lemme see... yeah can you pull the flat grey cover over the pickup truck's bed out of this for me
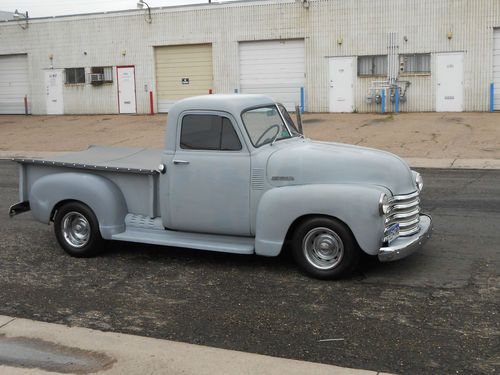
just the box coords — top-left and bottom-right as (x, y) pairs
(13, 146), (162, 174)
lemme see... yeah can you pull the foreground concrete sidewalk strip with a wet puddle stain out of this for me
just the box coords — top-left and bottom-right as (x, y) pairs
(0, 316), (386, 375)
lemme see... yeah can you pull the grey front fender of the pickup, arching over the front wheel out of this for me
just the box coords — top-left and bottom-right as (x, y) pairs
(255, 184), (389, 256)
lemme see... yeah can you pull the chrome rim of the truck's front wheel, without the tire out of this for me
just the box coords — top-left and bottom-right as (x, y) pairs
(302, 227), (344, 270)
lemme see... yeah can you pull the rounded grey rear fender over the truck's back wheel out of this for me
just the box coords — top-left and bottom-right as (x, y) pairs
(29, 172), (127, 239)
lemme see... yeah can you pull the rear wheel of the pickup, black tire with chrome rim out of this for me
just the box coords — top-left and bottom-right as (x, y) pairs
(54, 202), (104, 258)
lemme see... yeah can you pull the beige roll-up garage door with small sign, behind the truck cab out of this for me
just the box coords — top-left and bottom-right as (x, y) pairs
(155, 44), (213, 112)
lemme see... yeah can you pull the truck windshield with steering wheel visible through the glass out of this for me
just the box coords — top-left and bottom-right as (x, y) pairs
(241, 105), (292, 147)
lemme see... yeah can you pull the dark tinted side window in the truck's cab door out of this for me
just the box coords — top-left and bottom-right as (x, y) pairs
(180, 115), (241, 151)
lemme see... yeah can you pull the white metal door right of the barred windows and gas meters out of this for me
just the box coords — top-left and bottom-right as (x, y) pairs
(436, 52), (464, 112)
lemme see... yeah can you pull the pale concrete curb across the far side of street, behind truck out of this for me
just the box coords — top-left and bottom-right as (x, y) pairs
(0, 151), (500, 169)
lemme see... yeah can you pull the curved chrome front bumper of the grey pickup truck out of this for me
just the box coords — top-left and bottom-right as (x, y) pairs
(378, 215), (432, 262)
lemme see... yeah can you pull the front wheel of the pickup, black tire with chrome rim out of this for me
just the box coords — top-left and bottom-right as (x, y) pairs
(292, 217), (360, 279)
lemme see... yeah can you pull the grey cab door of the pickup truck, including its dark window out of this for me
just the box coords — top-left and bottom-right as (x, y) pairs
(162, 112), (250, 236)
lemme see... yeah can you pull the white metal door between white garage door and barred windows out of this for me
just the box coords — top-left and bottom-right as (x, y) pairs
(328, 57), (354, 112)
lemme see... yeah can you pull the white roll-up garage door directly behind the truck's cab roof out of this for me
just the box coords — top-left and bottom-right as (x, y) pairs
(239, 39), (305, 110)
